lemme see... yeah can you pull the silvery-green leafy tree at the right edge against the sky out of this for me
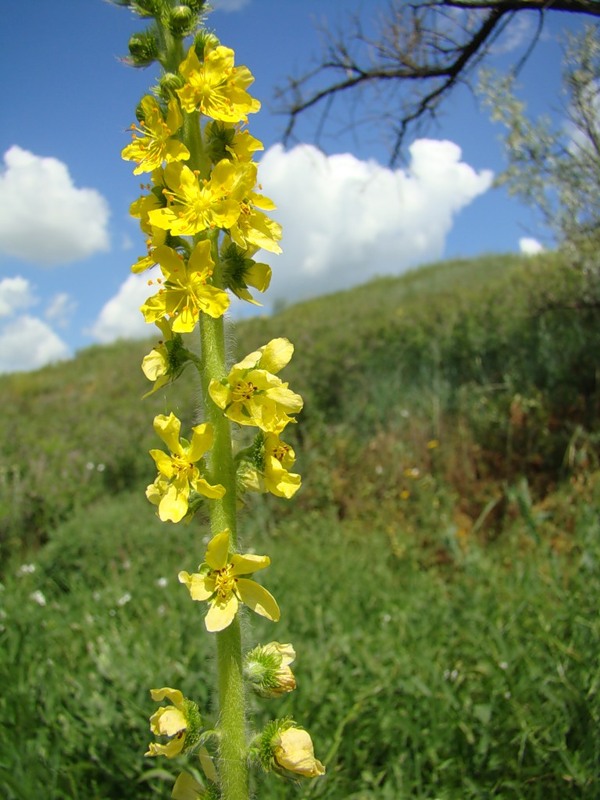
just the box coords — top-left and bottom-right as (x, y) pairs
(481, 25), (600, 252)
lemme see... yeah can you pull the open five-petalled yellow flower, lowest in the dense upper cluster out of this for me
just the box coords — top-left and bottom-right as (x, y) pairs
(141, 240), (229, 333)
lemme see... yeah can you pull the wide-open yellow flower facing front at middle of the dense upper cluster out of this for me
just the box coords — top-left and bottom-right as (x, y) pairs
(148, 159), (256, 236)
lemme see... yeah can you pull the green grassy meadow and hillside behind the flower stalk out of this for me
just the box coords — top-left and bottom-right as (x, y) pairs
(0, 254), (600, 800)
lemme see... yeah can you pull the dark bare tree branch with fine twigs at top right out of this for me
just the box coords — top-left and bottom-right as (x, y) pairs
(277, 0), (600, 163)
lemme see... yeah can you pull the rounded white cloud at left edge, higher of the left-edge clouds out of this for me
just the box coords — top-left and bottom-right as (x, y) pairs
(0, 146), (109, 265)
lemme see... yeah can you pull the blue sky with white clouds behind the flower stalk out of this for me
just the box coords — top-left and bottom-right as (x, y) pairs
(0, 0), (577, 372)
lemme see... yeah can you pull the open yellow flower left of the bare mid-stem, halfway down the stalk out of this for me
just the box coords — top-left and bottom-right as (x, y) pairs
(146, 412), (225, 522)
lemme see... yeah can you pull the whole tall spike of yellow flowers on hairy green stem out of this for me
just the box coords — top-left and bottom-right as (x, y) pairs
(120, 0), (324, 799)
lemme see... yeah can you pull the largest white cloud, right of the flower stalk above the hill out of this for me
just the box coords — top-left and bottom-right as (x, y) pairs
(259, 139), (493, 300)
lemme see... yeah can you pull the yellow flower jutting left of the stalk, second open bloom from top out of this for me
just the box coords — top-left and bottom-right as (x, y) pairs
(121, 95), (190, 175)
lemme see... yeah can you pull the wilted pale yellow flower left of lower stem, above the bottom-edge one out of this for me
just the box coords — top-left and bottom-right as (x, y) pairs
(145, 686), (202, 758)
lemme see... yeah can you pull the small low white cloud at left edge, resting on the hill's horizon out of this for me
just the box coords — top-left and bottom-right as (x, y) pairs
(0, 315), (70, 373)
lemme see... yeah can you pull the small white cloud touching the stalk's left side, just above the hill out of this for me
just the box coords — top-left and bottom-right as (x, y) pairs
(87, 267), (157, 344)
